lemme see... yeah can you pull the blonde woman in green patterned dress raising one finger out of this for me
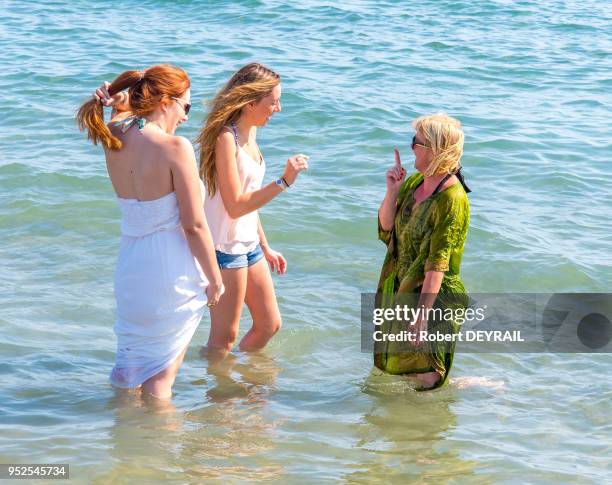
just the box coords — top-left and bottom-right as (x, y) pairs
(374, 114), (470, 390)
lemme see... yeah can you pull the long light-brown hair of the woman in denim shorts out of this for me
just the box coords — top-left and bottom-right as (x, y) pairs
(197, 62), (280, 196)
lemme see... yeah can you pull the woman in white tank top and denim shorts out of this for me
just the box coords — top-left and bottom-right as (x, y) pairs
(198, 63), (308, 356)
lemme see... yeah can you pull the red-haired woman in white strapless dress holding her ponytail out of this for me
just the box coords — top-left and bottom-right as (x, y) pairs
(77, 65), (223, 399)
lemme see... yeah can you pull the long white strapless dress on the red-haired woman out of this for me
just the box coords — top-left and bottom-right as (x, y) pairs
(110, 184), (208, 388)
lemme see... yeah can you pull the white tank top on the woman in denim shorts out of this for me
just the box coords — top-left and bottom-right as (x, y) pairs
(204, 123), (266, 254)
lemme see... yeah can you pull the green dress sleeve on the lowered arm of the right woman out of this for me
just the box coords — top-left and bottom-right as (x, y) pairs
(424, 199), (465, 272)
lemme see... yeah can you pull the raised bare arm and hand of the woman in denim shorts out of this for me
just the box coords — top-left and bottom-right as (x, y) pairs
(215, 131), (308, 219)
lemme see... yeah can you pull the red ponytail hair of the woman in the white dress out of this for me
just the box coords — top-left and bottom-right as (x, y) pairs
(76, 64), (190, 150)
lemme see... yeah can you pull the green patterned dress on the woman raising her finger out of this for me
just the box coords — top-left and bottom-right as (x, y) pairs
(374, 172), (470, 387)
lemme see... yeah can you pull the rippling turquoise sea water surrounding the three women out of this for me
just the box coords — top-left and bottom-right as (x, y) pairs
(0, 0), (612, 484)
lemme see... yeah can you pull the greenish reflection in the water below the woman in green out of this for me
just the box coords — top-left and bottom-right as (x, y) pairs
(344, 369), (476, 484)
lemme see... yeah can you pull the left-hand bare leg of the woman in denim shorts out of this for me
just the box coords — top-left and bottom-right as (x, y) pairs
(207, 268), (247, 354)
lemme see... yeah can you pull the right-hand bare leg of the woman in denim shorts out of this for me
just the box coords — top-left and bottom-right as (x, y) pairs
(240, 258), (281, 351)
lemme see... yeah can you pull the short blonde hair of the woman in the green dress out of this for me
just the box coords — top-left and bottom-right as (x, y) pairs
(412, 113), (464, 177)
